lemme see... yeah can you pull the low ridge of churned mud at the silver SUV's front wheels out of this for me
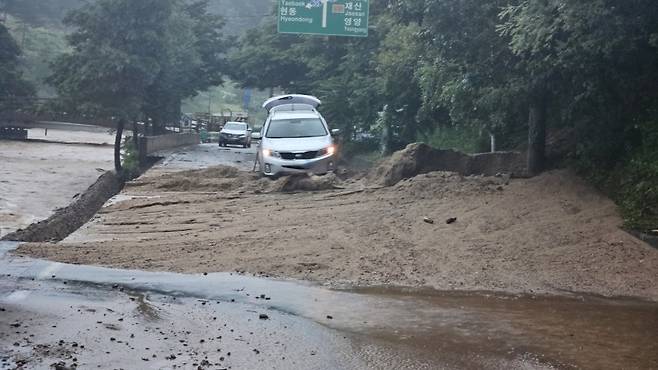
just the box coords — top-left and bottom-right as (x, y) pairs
(127, 166), (339, 193)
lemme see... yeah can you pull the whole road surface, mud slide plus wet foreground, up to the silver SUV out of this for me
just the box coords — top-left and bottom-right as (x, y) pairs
(5, 145), (658, 369)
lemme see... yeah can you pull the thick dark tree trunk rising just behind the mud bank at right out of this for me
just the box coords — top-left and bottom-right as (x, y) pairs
(528, 89), (547, 176)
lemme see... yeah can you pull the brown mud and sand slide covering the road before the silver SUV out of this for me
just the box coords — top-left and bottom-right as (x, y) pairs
(19, 144), (658, 301)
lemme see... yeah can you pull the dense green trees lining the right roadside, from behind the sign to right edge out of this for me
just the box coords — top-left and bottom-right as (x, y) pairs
(230, 0), (658, 229)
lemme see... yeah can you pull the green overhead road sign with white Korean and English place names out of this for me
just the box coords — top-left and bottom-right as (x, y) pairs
(278, 0), (370, 37)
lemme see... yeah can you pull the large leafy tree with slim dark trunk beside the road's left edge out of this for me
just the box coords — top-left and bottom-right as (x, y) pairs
(49, 0), (223, 172)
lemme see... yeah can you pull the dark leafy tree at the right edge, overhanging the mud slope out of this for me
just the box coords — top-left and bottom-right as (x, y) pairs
(500, 0), (658, 225)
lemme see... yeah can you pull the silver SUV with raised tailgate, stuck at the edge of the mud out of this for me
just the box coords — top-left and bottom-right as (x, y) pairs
(258, 95), (338, 176)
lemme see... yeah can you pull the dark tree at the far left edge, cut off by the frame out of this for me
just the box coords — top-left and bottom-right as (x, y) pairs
(0, 23), (34, 111)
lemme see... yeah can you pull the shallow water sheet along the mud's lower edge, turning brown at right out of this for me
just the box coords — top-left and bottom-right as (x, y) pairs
(0, 243), (658, 369)
